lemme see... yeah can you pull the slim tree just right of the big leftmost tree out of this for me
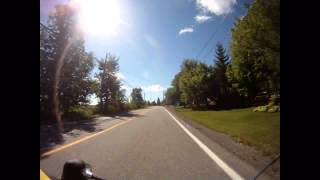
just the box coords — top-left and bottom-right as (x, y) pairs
(96, 53), (124, 113)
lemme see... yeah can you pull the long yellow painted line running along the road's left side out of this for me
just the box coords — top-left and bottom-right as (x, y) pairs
(41, 119), (132, 157)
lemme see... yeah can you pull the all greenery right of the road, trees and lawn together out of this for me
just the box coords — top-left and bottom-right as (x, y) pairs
(164, 0), (280, 154)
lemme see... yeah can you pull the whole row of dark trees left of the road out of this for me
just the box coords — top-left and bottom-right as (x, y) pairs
(40, 5), (145, 120)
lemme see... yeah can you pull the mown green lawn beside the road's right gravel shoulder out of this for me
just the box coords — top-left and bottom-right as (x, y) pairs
(176, 108), (280, 156)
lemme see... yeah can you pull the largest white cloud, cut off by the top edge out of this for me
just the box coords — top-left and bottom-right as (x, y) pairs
(196, 0), (237, 16)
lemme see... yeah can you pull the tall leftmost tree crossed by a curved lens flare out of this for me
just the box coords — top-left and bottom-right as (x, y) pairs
(40, 5), (94, 120)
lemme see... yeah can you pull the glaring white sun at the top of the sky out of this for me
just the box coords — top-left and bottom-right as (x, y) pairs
(70, 0), (123, 36)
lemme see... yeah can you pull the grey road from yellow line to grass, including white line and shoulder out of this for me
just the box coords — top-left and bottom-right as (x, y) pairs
(40, 107), (268, 180)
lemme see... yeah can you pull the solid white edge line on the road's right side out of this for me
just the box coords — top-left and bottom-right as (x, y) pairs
(163, 107), (244, 180)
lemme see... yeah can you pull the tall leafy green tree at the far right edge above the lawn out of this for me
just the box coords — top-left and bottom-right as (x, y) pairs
(228, 0), (280, 105)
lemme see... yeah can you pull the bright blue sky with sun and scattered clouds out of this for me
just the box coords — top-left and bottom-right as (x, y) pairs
(40, 0), (251, 103)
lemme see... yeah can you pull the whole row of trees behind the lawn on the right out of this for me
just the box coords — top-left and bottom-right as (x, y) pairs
(164, 0), (280, 109)
